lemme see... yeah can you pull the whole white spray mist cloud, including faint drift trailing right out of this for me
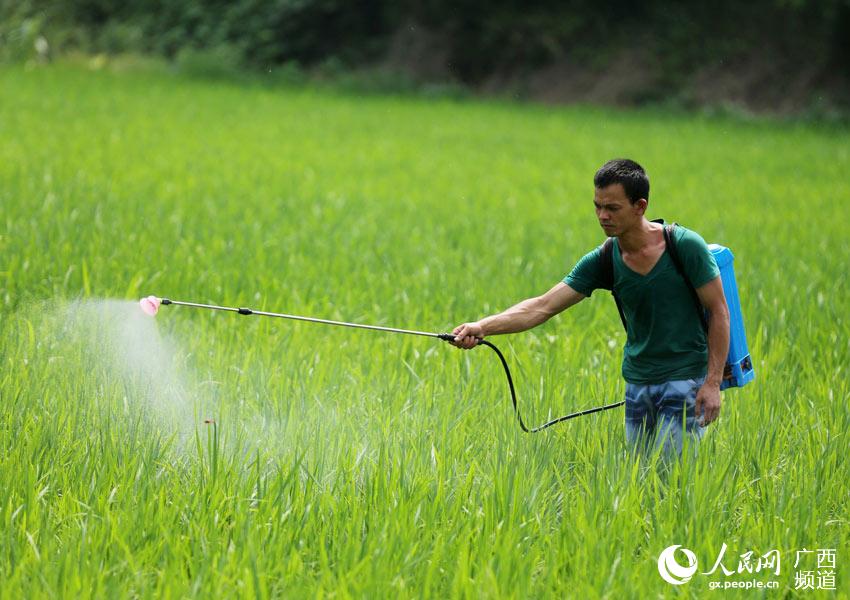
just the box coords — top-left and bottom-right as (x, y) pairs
(6, 299), (364, 456)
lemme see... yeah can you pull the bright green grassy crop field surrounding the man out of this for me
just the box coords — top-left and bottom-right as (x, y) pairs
(0, 65), (850, 598)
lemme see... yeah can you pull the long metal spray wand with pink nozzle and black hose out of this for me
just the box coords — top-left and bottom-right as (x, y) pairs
(139, 296), (624, 433)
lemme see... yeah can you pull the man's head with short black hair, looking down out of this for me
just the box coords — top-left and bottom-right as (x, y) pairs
(593, 158), (649, 236)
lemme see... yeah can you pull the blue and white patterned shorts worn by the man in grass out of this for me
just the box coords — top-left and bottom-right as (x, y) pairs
(626, 377), (705, 455)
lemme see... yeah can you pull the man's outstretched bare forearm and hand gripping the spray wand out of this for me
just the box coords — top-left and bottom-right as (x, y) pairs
(452, 282), (586, 349)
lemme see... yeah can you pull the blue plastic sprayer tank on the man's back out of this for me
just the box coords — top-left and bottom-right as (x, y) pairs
(708, 244), (756, 390)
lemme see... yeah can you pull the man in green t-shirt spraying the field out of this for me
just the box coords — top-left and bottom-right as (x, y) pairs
(452, 159), (729, 454)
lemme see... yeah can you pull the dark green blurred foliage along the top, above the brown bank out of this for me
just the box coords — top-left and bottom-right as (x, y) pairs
(0, 0), (850, 102)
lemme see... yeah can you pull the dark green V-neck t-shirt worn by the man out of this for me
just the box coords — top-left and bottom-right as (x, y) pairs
(564, 225), (720, 385)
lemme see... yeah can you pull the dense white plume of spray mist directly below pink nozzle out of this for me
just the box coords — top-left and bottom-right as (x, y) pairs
(9, 300), (202, 447)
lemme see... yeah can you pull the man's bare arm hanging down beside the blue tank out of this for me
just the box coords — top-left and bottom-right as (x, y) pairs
(696, 277), (729, 425)
